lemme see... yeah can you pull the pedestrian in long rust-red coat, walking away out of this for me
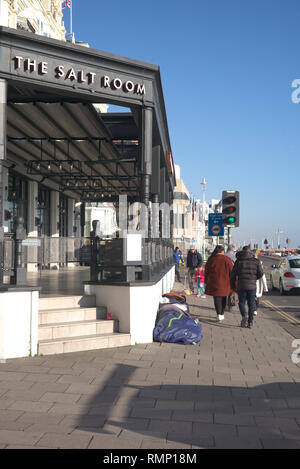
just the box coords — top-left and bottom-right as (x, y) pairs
(205, 245), (233, 321)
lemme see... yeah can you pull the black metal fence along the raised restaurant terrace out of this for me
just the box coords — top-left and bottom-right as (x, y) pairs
(0, 233), (173, 285)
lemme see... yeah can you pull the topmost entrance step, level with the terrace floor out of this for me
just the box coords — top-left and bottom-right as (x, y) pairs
(39, 295), (96, 311)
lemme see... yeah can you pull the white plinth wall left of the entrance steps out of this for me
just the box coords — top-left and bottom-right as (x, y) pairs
(0, 291), (39, 360)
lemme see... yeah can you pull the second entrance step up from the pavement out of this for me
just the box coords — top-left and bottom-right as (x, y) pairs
(39, 320), (118, 340)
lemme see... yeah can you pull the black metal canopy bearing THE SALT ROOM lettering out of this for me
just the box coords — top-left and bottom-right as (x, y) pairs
(0, 27), (175, 200)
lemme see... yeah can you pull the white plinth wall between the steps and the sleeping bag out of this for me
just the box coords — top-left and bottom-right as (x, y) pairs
(85, 267), (175, 345)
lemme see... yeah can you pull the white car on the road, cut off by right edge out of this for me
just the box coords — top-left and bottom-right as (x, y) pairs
(270, 256), (300, 295)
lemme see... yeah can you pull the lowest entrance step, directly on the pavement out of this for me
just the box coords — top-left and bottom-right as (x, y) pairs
(38, 333), (131, 355)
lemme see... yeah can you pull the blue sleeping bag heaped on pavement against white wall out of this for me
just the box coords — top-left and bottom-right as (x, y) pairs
(153, 305), (202, 345)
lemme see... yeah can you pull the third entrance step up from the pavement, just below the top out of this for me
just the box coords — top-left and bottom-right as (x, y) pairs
(39, 306), (107, 324)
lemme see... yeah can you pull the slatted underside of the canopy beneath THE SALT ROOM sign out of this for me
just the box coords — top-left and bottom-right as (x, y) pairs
(7, 102), (140, 199)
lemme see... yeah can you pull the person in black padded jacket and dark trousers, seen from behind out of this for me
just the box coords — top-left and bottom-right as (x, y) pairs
(230, 246), (264, 328)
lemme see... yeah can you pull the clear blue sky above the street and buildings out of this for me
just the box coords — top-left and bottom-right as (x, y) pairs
(64, 0), (300, 247)
